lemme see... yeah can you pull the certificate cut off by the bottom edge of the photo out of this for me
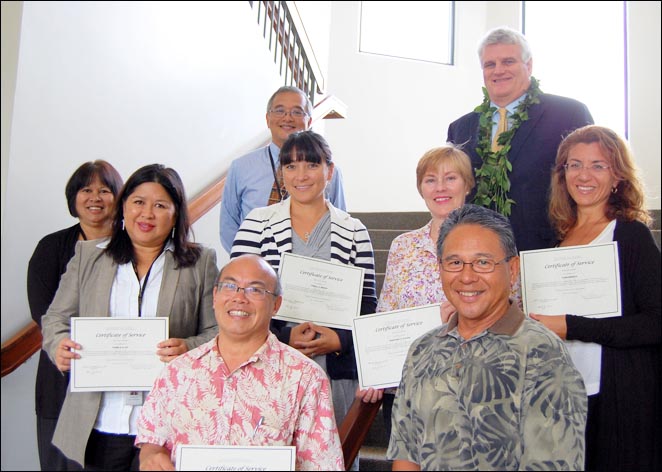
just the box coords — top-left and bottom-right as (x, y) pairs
(176, 445), (296, 470)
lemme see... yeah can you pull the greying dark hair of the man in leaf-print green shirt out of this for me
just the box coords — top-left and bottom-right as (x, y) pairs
(437, 203), (517, 259)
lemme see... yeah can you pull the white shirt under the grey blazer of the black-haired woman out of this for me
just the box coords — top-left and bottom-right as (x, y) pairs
(94, 241), (173, 435)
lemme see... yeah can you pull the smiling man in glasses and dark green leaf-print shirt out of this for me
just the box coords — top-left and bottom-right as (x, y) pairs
(387, 204), (587, 470)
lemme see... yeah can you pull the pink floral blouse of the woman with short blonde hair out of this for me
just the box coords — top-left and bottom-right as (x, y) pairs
(377, 221), (446, 312)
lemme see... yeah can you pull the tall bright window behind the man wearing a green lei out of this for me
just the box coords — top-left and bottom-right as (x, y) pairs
(523, 1), (628, 138)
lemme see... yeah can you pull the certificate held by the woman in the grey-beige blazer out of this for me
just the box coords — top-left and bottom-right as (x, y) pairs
(69, 317), (168, 392)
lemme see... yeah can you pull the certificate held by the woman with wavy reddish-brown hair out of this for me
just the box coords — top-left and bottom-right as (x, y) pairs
(520, 242), (621, 318)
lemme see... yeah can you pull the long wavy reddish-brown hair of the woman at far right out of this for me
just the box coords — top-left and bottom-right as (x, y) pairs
(549, 125), (651, 239)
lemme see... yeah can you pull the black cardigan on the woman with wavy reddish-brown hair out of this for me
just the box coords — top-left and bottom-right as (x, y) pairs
(566, 221), (662, 470)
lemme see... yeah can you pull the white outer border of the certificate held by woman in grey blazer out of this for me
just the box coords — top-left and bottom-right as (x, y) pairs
(69, 316), (169, 392)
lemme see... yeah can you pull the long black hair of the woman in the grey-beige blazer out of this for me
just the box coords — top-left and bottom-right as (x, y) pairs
(106, 164), (201, 267)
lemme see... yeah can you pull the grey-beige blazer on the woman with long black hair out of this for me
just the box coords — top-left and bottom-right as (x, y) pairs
(42, 241), (218, 465)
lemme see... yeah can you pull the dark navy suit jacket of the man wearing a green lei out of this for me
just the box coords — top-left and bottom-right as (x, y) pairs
(447, 94), (593, 251)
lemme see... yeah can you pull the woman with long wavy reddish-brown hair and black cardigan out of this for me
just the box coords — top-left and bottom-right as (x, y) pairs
(531, 126), (662, 471)
